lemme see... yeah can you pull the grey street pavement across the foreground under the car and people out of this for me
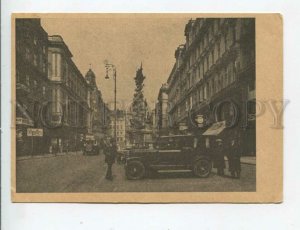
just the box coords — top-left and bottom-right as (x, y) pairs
(17, 152), (256, 192)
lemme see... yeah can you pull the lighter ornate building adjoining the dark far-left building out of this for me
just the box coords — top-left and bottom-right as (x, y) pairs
(48, 35), (92, 151)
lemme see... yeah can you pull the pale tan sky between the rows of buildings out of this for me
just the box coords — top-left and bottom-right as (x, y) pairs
(42, 15), (189, 108)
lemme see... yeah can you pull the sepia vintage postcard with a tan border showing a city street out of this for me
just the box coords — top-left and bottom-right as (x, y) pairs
(11, 13), (285, 203)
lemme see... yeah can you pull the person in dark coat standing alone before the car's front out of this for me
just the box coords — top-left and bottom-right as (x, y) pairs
(103, 138), (117, 180)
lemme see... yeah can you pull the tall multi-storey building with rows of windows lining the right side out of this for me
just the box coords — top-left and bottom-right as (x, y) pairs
(167, 18), (255, 154)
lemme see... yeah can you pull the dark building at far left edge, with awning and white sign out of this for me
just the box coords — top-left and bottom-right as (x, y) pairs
(15, 19), (48, 155)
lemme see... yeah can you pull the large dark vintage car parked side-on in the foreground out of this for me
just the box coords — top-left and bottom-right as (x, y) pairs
(125, 135), (212, 180)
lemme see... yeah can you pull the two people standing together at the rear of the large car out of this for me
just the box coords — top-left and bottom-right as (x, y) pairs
(213, 139), (241, 178)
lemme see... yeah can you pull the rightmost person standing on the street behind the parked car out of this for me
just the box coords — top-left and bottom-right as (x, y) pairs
(227, 139), (241, 178)
